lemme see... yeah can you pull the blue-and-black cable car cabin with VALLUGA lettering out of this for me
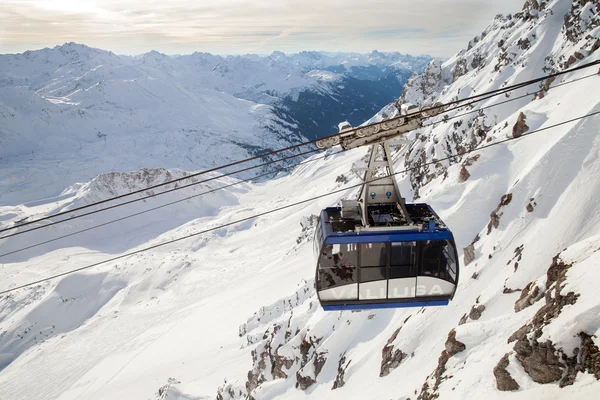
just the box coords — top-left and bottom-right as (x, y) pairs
(314, 204), (458, 311)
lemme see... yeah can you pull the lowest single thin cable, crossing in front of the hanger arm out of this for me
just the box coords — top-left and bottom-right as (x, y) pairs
(0, 111), (600, 295)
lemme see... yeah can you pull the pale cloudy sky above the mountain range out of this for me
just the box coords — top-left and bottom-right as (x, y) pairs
(0, 0), (525, 57)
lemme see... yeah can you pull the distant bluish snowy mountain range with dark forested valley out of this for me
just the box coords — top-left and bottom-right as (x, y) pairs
(0, 43), (429, 204)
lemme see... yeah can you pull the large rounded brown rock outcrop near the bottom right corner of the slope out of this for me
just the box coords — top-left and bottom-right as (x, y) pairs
(514, 338), (563, 383)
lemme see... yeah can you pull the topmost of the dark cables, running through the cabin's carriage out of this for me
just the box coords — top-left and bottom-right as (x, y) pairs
(0, 60), (600, 233)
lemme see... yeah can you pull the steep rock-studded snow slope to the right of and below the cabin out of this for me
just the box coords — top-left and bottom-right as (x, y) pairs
(211, 0), (600, 399)
